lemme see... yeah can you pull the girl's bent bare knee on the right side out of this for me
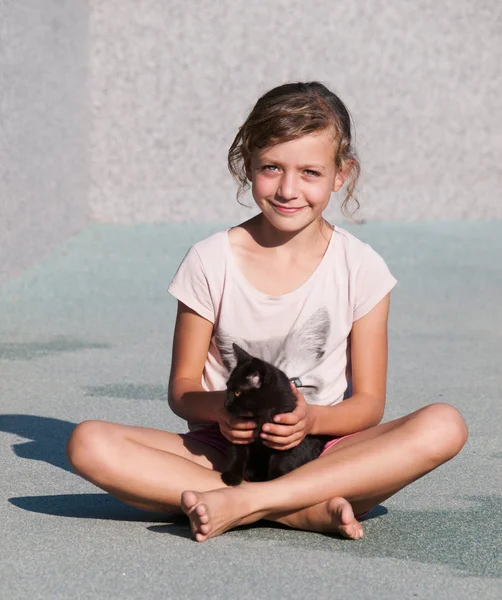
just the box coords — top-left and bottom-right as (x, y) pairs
(423, 403), (468, 460)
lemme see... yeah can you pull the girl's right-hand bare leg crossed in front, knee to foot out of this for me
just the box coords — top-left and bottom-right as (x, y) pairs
(182, 404), (467, 541)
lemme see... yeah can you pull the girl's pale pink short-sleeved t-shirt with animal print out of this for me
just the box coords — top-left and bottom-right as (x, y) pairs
(169, 227), (396, 406)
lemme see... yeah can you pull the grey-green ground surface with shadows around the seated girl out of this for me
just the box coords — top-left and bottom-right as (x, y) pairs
(0, 222), (502, 600)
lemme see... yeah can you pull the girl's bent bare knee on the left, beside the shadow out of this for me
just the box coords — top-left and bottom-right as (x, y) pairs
(66, 421), (114, 474)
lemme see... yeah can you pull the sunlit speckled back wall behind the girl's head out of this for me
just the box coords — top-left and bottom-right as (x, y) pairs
(90, 0), (502, 222)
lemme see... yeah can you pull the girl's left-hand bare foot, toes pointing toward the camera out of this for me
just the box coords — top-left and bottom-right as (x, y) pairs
(181, 483), (260, 542)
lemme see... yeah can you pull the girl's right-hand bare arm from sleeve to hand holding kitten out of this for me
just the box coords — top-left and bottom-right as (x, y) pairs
(261, 294), (390, 450)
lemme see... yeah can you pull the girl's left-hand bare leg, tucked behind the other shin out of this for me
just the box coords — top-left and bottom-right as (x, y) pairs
(67, 421), (231, 513)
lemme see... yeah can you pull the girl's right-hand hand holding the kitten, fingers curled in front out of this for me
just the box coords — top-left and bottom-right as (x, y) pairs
(260, 383), (313, 450)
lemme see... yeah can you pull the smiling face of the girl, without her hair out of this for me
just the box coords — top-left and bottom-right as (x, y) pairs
(246, 131), (345, 232)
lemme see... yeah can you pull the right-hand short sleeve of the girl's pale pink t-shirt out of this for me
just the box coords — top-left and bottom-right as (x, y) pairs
(353, 244), (397, 321)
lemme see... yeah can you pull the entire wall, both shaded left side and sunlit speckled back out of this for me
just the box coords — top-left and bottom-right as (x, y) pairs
(0, 0), (502, 280)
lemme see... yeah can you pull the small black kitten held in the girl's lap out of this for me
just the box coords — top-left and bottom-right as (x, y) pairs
(221, 344), (329, 485)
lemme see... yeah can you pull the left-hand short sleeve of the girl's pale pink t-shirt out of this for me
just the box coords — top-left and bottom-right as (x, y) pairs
(167, 246), (216, 323)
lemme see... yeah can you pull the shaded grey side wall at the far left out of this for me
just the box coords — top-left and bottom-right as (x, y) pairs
(0, 0), (89, 281)
